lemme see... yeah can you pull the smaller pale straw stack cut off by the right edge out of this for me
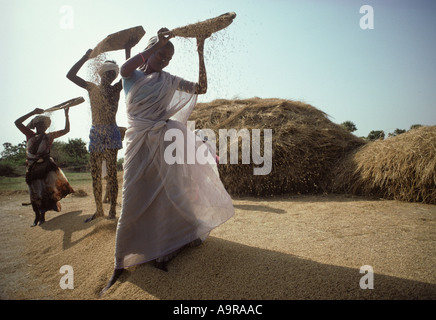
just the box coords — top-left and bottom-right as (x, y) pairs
(333, 126), (436, 204)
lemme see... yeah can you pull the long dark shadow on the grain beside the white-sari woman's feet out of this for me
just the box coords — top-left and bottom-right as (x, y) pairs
(113, 237), (436, 300)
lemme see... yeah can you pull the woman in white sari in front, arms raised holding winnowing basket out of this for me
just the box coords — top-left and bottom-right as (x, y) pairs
(103, 28), (234, 292)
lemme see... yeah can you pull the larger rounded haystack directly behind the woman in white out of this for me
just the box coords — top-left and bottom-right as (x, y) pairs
(190, 98), (365, 196)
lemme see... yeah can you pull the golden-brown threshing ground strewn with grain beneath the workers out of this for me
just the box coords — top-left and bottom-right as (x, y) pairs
(0, 184), (436, 300)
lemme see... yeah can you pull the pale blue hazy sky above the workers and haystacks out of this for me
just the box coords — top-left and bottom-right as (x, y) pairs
(0, 0), (436, 158)
